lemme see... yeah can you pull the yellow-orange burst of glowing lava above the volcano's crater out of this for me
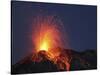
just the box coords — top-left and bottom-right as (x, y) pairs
(32, 15), (69, 56)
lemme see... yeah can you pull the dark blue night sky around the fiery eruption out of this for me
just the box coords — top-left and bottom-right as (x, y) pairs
(11, 1), (97, 64)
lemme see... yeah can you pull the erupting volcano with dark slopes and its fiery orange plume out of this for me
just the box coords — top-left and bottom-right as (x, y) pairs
(12, 15), (97, 74)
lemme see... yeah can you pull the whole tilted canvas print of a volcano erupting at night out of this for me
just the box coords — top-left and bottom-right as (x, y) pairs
(11, 1), (97, 74)
